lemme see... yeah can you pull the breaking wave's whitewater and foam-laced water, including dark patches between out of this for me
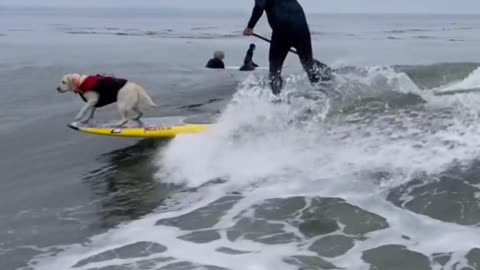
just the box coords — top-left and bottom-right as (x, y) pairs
(31, 67), (480, 270)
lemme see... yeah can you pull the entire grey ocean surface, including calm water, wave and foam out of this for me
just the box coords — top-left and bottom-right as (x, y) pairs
(0, 7), (480, 270)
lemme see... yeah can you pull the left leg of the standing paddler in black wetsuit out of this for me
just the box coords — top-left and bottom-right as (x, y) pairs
(269, 32), (290, 95)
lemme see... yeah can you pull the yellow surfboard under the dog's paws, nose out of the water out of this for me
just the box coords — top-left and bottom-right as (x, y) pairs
(68, 117), (213, 139)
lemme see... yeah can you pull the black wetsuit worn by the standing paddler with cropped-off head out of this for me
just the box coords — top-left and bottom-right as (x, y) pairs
(248, 0), (320, 94)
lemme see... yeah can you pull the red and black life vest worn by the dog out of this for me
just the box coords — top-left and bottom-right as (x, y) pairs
(75, 74), (128, 108)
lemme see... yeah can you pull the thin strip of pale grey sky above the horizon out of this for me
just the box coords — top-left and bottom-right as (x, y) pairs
(0, 0), (480, 14)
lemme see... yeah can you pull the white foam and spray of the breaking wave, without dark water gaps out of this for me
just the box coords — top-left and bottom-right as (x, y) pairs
(30, 66), (480, 270)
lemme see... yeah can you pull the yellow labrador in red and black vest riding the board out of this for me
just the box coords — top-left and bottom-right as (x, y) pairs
(57, 73), (157, 126)
